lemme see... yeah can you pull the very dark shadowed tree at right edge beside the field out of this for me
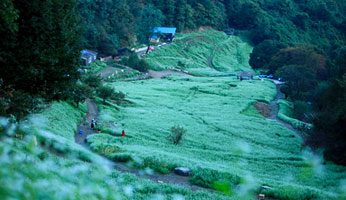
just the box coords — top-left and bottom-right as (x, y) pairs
(308, 74), (346, 165)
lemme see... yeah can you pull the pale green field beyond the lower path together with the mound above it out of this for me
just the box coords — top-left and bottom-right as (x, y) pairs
(88, 30), (346, 199)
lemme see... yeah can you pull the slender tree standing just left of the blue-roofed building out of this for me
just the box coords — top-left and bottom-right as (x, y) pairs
(137, 4), (164, 53)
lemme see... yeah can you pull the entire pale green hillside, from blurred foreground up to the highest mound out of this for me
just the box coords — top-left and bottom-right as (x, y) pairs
(0, 30), (346, 200)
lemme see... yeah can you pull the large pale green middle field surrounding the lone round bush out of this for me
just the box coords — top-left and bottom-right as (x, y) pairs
(89, 77), (340, 196)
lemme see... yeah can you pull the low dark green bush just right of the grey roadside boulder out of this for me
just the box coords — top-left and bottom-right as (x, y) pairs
(190, 169), (240, 188)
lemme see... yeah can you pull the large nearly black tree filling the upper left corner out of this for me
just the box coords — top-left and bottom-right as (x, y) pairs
(0, 0), (81, 100)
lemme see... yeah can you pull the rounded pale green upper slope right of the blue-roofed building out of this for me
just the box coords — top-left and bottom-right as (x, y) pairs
(145, 30), (252, 76)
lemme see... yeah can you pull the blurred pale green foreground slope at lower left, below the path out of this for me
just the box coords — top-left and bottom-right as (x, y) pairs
(0, 102), (230, 200)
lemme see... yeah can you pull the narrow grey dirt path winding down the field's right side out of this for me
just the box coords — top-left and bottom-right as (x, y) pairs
(269, 82), (303, 140)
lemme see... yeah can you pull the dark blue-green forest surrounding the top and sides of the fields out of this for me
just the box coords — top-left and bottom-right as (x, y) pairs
(0, 0), (346, 172)
